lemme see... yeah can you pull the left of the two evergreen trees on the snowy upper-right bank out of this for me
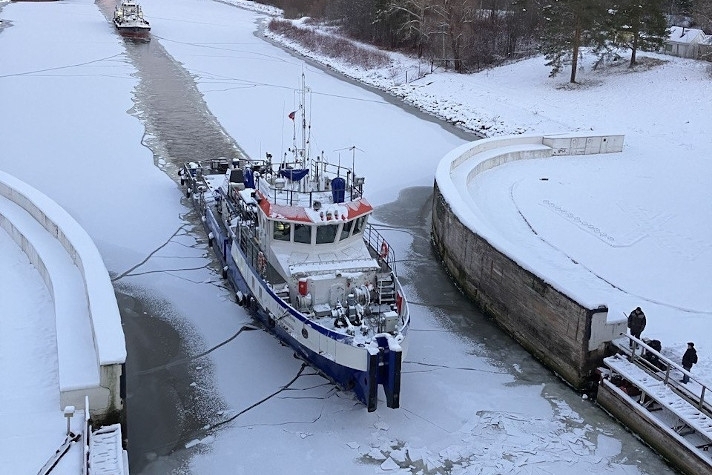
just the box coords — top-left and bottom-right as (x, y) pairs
(540, 0), (606, 83)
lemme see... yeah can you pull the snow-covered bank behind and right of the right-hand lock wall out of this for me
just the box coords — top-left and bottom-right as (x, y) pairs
(253, 2), (712, 374)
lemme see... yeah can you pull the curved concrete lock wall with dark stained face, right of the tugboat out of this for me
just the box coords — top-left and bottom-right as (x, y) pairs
(432, 135), (626, 389)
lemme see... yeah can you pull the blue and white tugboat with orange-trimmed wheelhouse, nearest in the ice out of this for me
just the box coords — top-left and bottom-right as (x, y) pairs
(180, 74), (410, 412)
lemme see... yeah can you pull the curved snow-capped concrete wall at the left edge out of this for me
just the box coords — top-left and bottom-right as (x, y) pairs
(0, 171), (126, 420)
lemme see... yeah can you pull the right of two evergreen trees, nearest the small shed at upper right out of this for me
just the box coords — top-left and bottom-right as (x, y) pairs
(612, 0), (668, 67)
